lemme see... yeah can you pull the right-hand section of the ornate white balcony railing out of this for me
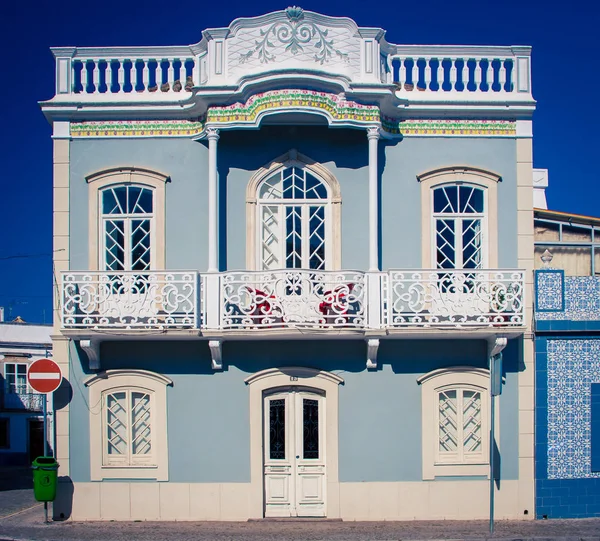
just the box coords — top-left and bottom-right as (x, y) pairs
(387, 269), (525, 328)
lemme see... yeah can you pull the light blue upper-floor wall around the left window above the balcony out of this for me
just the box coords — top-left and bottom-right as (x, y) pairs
(70, 139), (208, 270)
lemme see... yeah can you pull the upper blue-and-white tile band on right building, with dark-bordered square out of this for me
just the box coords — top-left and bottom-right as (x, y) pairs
(535, 270), (600, 321)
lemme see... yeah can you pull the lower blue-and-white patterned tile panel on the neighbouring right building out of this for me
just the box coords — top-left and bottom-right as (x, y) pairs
(538, 338), (600, 479)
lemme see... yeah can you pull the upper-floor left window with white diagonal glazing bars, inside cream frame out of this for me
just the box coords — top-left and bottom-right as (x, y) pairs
(101, 185), (154, 271)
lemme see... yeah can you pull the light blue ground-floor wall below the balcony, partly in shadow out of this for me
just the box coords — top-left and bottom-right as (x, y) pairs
(70, 340), (521, 482)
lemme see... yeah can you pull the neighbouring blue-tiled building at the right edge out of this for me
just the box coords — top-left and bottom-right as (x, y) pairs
(535, 205), (600, 518)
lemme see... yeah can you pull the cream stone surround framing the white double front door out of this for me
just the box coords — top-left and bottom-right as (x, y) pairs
(245, 367), (343, 518)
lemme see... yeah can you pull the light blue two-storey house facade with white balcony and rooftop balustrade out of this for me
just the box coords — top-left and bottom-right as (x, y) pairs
(41, 8), (535, 520)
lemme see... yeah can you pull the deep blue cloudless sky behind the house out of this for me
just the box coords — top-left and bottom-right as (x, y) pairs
(0, 0), (600, 323)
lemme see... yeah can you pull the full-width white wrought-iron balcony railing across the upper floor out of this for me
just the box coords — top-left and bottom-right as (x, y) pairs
(61, 269), (525, 337)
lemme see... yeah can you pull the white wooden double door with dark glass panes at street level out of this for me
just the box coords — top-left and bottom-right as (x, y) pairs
(263, 388), (326, 517)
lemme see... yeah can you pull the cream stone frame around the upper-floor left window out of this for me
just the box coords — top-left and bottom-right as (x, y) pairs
(86, 167), (169, 270)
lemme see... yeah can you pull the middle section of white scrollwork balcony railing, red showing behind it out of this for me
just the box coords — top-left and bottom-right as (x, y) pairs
(221, 269), (367, 329)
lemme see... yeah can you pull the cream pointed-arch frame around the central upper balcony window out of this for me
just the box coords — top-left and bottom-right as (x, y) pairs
(246, 149), (342, 270)
